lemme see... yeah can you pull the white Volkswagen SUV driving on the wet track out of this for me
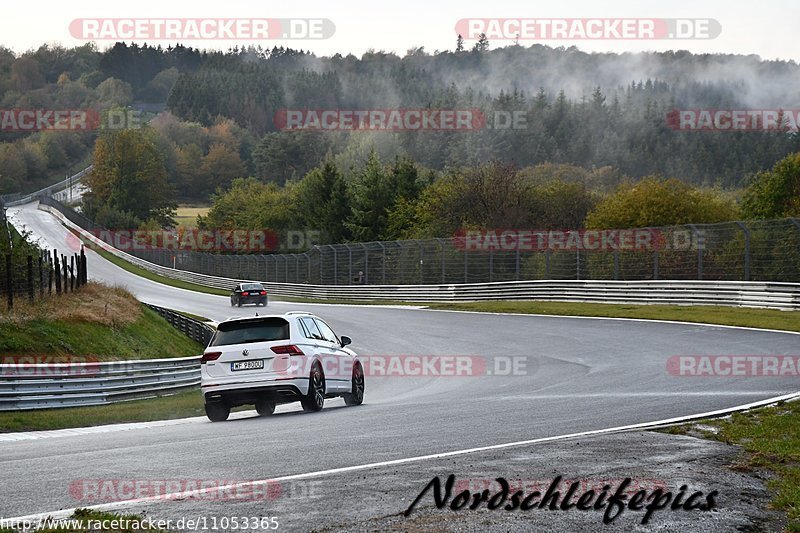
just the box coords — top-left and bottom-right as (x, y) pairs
(200, 312), (364, 422)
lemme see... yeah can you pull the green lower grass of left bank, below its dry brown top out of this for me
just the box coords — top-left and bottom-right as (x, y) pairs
(0, 308), (203, 361)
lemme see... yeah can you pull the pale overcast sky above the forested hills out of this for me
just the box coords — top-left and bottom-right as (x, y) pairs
(0, 0), (800, 62)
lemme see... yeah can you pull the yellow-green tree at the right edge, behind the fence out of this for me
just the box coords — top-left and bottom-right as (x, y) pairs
(742, 153), (800, 219)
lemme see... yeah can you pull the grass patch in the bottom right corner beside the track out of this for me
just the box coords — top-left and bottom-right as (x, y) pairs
(666, 401), (800, 533)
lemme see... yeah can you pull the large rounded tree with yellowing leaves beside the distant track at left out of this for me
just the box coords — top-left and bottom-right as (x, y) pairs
(84, 129), (176, 226)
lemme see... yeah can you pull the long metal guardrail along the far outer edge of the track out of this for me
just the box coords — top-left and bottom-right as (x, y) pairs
(40, 204), (800, 310)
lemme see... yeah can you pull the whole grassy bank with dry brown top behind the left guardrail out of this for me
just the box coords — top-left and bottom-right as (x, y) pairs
(0, 283), (202, 362)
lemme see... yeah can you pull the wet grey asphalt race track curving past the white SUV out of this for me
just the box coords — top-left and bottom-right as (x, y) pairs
(6, 204), (800, 530)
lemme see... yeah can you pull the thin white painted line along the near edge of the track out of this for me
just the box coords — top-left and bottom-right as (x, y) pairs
(5, 392), (800, 527)
